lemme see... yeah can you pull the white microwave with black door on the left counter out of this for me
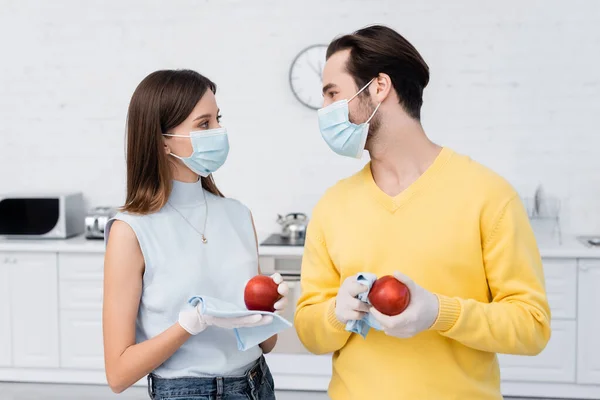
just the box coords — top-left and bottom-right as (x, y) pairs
(0, 192), (85, 239)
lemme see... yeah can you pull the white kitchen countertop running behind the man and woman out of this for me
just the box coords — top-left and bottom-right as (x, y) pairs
(0, 236), (600, 258)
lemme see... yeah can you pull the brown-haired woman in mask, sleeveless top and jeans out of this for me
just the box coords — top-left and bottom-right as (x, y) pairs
(103, 70), (287, 400)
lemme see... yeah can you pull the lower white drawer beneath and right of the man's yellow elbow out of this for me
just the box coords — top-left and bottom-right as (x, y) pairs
(498, 321), (577, 383)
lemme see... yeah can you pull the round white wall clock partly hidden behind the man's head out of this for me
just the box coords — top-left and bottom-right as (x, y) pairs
(289, 44), (327, 110)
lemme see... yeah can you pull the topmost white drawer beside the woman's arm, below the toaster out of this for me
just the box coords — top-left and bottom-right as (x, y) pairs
(58, 253), (104, 281)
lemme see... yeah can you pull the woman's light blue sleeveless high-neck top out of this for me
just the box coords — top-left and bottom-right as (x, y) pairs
(105, 181), (262, 378)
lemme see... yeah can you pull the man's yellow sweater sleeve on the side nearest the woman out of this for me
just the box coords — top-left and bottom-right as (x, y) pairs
(294, 206), (350, 354)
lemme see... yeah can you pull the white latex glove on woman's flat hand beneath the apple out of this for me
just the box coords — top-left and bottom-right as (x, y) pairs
(178, 304), (273, 335)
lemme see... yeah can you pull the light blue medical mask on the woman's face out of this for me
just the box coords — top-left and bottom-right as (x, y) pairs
(163, 128), (229, 178)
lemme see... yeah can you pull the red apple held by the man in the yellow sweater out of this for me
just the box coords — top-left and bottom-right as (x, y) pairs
(369, 275), (410, 316)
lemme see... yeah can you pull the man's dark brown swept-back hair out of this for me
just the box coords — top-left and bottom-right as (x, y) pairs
(327, 25), (429, 120)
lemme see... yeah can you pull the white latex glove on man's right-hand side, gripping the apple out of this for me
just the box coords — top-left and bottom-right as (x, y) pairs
(370, 272), (440, 338)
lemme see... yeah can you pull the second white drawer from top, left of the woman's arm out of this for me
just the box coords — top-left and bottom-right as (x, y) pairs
(59, 281), (103, 310)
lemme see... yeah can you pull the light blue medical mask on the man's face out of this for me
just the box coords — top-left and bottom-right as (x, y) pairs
(317, 78), (381, 158)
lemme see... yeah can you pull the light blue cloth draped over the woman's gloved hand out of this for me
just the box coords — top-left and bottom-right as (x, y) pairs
(189, 296), (292, 351)
